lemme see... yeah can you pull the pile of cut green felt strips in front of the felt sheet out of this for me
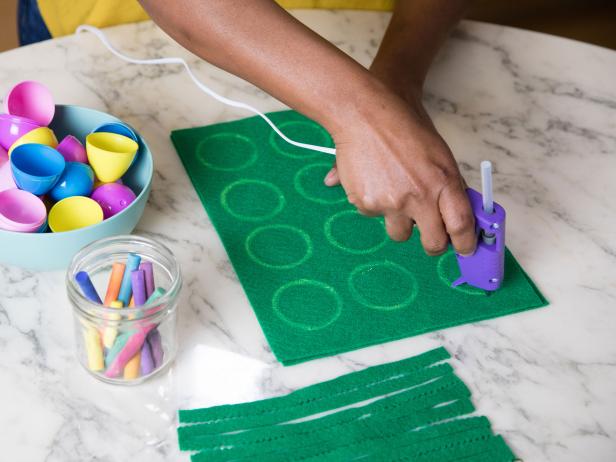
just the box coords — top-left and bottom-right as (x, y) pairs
(178, 348), (515, 462)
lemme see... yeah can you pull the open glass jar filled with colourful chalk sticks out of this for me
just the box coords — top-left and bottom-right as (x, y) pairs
(66, 235), (182, 385)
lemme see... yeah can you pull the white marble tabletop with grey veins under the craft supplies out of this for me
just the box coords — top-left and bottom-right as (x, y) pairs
(0, 11), (616, 462)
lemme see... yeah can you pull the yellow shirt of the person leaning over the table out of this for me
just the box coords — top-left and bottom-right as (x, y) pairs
(38, 0), (395, 37)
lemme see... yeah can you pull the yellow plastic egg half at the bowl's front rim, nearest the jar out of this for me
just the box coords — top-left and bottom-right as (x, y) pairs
(48, 196), (103, 233)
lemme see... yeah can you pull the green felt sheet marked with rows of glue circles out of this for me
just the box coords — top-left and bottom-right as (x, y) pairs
(171, 111), (546, 365)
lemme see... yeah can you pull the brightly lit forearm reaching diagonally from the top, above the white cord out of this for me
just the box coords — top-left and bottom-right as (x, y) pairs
(140, 0), (384, 131)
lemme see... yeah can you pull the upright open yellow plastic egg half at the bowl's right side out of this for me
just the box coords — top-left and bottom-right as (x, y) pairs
(86, 132), (139, 183)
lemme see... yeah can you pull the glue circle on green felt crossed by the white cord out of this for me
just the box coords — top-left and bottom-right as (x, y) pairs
(269, 120), (332, 159)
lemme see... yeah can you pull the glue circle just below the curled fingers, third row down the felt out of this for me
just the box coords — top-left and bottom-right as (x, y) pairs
(324, 210), (388, 255)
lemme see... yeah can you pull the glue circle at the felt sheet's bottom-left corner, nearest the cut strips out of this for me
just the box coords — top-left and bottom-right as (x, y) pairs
(272, 279), (342, 331)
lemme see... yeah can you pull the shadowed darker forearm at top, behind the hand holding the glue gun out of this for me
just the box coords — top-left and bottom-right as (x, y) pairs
(371, 0), (469, 96)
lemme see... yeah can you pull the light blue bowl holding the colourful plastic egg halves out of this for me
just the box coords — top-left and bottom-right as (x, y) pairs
(0, 105), (154, 271)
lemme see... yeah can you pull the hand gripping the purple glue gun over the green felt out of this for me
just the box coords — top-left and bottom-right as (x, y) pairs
(325, 89), (476, 255)
